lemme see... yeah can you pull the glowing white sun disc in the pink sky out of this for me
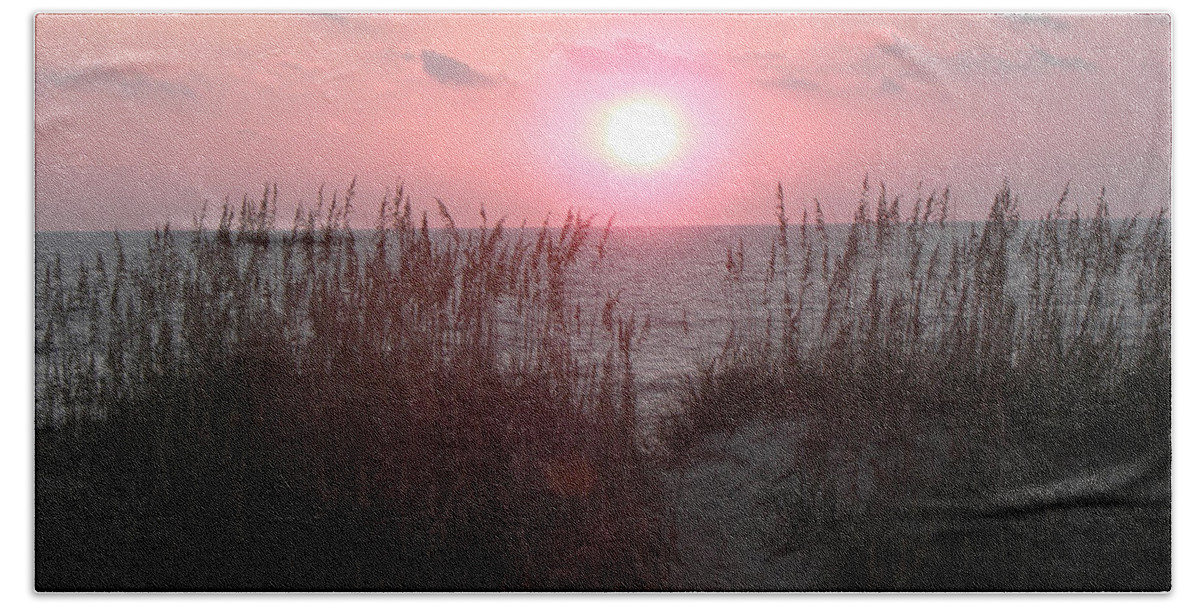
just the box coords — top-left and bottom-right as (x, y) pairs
(602, 97), (683, 170)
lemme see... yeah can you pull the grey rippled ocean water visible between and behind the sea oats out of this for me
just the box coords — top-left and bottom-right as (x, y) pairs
(35, 223), (1161, 429)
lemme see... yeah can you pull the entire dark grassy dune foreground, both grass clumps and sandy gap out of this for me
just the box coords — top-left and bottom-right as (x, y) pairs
(35, 185), (1171, 590)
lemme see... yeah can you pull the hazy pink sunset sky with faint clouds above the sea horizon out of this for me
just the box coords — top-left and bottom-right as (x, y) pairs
(35, 14), (1171, 230)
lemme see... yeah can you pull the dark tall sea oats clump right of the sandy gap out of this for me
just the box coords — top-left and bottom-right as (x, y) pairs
(667, 181), (1171, 590)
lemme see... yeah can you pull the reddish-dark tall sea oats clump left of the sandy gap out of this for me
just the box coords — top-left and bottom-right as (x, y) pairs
(37, 183), (670, 589)
